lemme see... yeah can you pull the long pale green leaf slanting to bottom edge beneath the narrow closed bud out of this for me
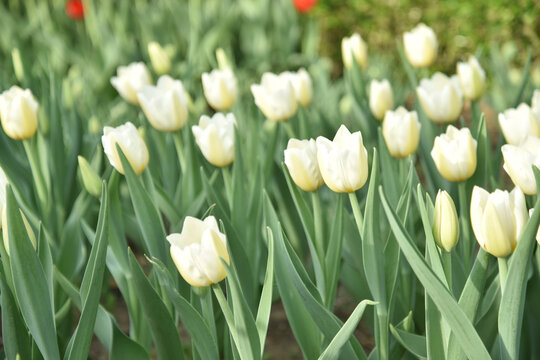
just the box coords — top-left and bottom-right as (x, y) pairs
(379, 188), (491, 359)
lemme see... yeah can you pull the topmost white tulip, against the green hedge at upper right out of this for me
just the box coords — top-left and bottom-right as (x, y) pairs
(403, 23), (438, 68)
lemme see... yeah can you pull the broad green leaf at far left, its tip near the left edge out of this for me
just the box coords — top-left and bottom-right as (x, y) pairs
(6, 185), (60, 360)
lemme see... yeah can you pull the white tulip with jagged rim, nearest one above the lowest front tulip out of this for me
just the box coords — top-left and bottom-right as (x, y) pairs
(191, 113), (236, 167)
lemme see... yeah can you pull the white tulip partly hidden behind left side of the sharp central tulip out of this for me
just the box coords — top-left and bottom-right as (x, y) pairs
(284, 139), (323, 191)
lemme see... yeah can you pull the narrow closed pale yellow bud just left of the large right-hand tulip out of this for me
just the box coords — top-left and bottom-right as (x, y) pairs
(433, 190), (459, 252)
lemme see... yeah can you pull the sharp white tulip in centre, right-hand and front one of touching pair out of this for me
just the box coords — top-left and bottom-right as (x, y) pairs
(317, 125), (368, 193)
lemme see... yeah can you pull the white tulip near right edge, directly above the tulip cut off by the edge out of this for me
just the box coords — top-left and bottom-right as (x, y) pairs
(499, 103), (540, 145)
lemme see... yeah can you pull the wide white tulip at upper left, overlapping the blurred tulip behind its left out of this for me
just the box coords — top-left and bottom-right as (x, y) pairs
(137, 75), (188, 132)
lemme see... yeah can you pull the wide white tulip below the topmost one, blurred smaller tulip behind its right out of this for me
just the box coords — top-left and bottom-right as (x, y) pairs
(416, 72), (463, 124)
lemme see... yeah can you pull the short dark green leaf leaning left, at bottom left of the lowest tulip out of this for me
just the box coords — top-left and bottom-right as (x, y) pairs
(128, 249), (184, 360)
